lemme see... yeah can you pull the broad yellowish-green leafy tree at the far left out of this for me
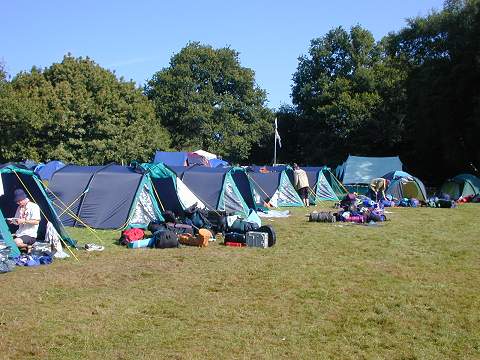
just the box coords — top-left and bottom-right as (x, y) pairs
(0, 55), (169, 164)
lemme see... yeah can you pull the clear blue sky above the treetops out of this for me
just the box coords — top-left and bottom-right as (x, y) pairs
(0, 0), (443, 108)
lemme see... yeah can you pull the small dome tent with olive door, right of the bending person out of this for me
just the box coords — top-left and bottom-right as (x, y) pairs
(382, 171), (427, 203)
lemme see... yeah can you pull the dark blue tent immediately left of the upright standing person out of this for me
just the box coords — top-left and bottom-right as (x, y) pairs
(247, 167), (303, 207)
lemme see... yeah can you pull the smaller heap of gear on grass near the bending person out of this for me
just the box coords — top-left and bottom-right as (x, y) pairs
(308, 193), (387, 224)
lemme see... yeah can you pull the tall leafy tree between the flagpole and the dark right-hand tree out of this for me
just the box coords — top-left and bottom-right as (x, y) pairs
(292, 26), (405, 165)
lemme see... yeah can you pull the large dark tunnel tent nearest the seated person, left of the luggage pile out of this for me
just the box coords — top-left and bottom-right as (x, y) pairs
(50, 164), (162, 229)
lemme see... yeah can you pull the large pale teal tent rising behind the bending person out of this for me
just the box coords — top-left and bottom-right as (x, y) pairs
(337, 155), (403, 185)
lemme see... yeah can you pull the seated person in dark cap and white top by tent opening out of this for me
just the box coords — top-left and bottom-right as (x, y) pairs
(9, 189), (40, 252)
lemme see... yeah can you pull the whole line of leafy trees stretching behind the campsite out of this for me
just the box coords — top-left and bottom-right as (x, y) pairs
(0, 0), (480, 183)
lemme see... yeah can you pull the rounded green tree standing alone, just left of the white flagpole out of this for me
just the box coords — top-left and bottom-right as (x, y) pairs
(145, 42), (273, 162)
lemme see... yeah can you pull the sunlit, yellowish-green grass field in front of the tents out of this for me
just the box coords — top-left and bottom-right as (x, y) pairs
(0, 204), (480, 359)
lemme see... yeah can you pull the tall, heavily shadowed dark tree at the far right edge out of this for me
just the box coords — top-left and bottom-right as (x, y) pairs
(386, 0), (480, 182)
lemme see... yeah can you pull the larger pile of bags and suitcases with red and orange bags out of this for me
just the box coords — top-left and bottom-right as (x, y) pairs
(119, 205), (276, 249)
